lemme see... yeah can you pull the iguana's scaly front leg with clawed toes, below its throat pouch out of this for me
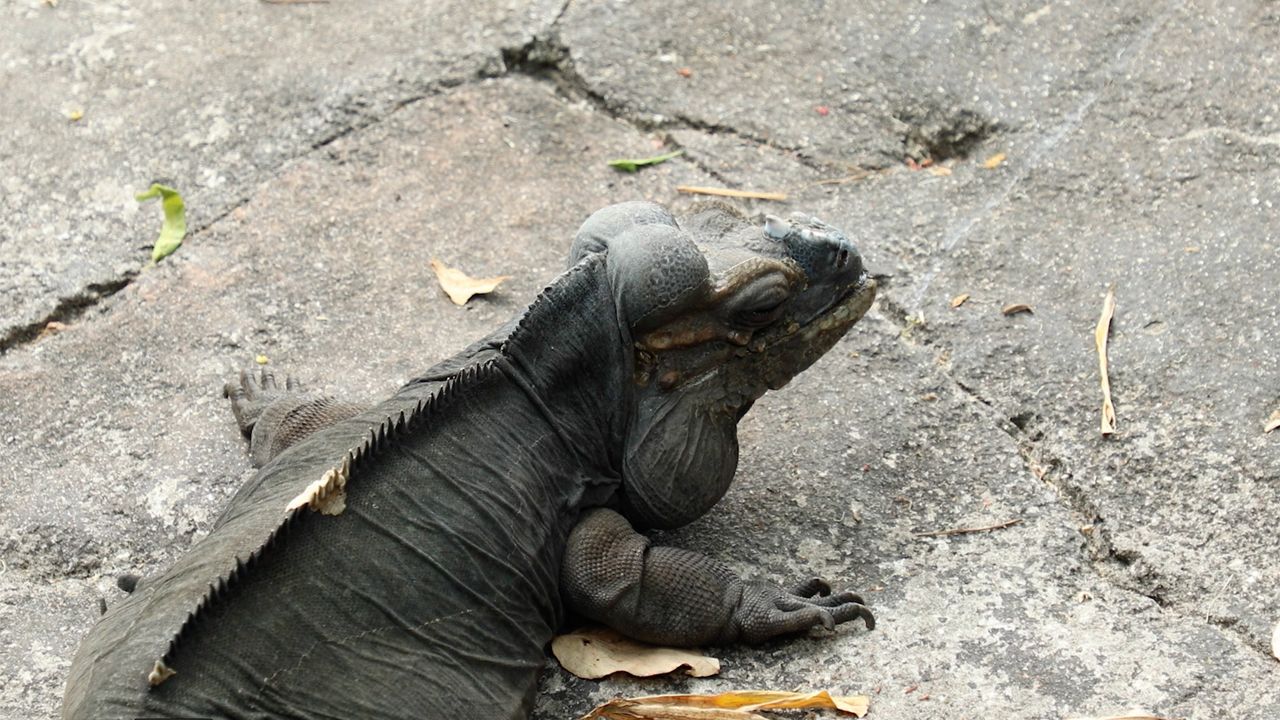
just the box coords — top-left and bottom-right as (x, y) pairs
(561, 509), (876, 646)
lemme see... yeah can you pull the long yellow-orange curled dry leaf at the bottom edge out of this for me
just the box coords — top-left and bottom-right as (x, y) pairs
(582, 691), (870, 720)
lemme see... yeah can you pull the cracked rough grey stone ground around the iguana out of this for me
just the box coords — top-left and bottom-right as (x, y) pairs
(0, 0), (1280, 720)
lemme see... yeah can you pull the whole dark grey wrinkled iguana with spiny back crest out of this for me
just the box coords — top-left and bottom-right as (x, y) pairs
(63, 202), (874, 720)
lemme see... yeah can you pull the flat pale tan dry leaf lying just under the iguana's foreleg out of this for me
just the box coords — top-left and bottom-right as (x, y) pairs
(552, 628), (719, 680)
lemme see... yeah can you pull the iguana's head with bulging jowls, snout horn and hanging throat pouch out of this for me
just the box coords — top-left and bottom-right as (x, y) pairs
(571, 202), (876, 528)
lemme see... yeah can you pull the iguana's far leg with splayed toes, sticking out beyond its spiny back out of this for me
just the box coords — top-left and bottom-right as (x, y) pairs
(223, 368), (364, 468)
